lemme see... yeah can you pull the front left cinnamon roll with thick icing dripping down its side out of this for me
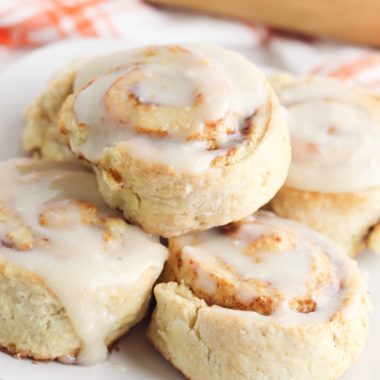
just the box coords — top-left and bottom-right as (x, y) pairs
(0, 159), (167, 364)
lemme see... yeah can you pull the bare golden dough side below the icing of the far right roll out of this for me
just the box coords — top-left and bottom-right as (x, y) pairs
(269, 186), (380, 256)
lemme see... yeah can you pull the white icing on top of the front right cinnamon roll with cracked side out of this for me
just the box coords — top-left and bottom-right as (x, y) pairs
(177, 212), (365, 324)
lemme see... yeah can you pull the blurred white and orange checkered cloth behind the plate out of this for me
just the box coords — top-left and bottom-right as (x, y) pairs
(0, 0), (380, 95)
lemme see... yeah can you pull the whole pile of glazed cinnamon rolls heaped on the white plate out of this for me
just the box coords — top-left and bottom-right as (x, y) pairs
(0, 44), (380, 380)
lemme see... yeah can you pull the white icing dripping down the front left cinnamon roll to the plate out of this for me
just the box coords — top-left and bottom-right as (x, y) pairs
(0, 159), (167, 364)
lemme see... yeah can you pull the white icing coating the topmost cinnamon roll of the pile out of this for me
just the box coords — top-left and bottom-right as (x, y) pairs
(72, 45), (269, 172)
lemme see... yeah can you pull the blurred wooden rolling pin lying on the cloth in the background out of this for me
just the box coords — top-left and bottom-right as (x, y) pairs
(149, 0), (380, 47)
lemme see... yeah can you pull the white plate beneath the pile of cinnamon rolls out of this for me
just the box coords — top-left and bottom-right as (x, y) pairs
(0, 39), (380, 380)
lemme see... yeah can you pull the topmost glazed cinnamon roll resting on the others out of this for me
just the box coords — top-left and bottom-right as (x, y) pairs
(59, 45), (290, 237)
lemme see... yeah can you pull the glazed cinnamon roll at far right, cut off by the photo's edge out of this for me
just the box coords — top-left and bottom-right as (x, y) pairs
(270, 75), (380, 255)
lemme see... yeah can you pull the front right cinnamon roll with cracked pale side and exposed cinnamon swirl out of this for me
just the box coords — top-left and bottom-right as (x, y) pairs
(148, 212), (371, 380)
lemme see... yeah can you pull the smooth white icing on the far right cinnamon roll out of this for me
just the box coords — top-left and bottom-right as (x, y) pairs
(278, 79), (380, 193)
